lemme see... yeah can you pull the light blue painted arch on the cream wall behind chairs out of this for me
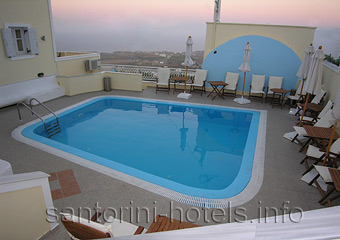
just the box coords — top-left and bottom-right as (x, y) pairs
(202, 35), (301, 92)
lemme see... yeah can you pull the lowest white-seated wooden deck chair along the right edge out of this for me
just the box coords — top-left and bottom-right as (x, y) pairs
(308, 165), (340, 207)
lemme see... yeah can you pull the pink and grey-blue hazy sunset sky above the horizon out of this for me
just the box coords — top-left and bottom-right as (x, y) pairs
(51, 0), (340, 55)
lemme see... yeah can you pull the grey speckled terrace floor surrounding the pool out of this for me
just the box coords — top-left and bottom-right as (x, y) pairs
(0, 88), (340, 239)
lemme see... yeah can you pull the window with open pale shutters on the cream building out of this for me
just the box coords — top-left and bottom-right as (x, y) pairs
(2, 23), (39, 60)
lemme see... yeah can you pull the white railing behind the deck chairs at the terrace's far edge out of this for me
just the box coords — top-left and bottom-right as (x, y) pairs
(102, 64), (196, 81)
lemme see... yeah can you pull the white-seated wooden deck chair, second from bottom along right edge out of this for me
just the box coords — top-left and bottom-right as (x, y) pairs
(300, 138), (340, 175)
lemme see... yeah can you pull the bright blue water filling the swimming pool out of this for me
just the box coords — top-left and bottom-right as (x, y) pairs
(22, 97), (260, 198)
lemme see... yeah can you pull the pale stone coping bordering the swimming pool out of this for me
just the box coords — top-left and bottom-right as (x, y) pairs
(11, 95), (267, 208)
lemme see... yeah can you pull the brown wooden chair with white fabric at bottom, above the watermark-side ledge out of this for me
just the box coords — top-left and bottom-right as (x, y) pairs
(60, 213), (147, 239)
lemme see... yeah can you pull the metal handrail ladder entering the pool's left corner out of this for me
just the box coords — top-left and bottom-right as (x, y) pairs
(17, 98), (61, 138)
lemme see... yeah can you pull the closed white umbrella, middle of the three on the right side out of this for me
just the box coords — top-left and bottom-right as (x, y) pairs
(300, 46), (325, 126)
